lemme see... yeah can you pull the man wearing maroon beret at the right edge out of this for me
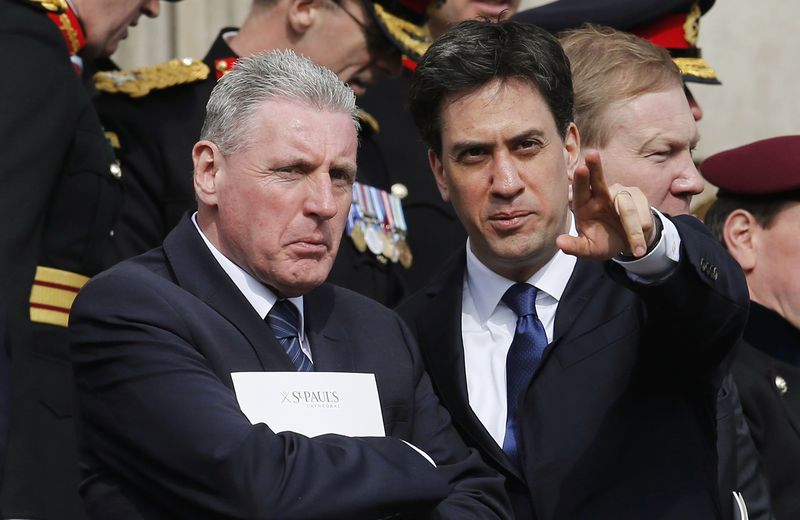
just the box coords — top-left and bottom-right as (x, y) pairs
(700, 135), (800, 520)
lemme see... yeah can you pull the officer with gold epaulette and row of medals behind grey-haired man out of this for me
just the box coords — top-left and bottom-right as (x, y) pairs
(95, 0), (426, 304)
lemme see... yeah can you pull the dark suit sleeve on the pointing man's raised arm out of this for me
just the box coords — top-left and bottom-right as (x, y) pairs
(608, 216), (749, 374)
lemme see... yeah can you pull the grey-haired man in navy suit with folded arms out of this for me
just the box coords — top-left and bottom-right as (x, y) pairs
(70, 51), (510, 519)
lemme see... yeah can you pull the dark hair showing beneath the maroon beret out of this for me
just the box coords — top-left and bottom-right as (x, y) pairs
(703, 190), (800, 246)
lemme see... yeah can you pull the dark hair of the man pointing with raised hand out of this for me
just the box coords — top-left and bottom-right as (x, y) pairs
(410, 20), (574, 155)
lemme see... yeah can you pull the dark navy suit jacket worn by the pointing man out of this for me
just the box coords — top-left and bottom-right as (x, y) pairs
(400, 217), (747, 520)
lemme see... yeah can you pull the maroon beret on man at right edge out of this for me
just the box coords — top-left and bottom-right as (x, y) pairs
(700, 135), (800, 195)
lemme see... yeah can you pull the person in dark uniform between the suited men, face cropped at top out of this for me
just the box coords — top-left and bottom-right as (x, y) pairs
(359, 0), (519, 294)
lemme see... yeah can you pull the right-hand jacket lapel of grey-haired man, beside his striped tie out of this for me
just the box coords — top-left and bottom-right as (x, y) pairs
(303, 284), (358, 372)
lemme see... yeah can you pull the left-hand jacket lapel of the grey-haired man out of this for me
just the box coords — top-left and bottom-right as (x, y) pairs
(164, 217), (295, 371)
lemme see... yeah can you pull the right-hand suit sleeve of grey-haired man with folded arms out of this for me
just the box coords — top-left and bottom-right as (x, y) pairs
(397, 316), (511, 518)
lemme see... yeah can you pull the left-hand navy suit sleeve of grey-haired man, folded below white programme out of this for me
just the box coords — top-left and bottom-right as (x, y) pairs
(70, 274), (452, 519)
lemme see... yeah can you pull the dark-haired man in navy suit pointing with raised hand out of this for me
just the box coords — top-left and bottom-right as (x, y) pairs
(401, 22), (747, 520)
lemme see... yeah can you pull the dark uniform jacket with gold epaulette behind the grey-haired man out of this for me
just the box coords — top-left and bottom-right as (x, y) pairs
(95, 28), (404, 305)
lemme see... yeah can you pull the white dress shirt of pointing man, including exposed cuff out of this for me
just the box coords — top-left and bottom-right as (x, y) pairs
(461, 211), (680, 447)
